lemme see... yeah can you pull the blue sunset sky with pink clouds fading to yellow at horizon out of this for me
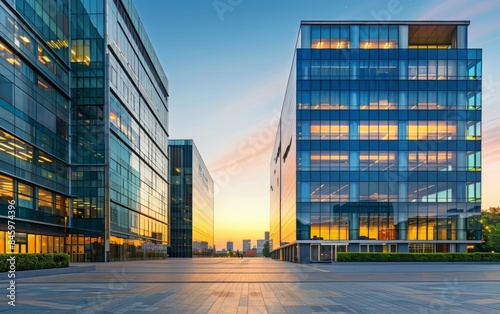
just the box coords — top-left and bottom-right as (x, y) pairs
(134, 0), (500, 250)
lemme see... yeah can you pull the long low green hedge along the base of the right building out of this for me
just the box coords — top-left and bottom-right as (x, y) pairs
(337, 253), (500, 262)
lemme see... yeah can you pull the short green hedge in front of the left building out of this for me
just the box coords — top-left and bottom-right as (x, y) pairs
(0, 253), (69, 272)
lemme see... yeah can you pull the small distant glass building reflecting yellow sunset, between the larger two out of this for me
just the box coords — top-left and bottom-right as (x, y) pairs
(168, 140), (215, 257)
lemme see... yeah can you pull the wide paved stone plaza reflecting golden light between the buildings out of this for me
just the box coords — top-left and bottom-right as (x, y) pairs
(0, 258), (500, 314)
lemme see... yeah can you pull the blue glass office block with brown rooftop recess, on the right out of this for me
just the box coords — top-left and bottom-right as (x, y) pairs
(270, 21), (482, 263)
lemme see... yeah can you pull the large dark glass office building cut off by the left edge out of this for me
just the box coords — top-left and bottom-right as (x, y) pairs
(0, 0), (168, 261)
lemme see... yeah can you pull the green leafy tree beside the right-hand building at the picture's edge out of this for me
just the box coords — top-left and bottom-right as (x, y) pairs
(478, 207), (500, 252)
